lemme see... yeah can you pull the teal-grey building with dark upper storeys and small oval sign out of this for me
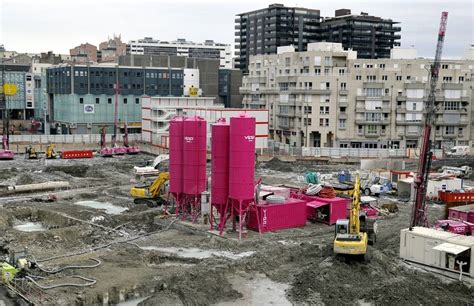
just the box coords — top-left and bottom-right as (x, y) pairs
(47, 65), (191, 134)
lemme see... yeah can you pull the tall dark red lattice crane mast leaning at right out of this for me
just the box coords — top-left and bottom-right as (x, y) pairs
(410, 12), (448, 230)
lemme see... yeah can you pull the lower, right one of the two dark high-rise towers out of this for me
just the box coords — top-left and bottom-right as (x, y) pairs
(320, 9), (401, 58)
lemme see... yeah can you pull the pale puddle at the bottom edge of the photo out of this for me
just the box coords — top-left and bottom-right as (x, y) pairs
(217, 274), (291, 306)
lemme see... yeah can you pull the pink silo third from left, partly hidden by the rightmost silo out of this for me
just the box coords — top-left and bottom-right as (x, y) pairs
(211, 118), (230, 205)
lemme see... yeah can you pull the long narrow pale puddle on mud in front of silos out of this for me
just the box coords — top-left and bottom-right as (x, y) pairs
(141, 246), (255, 260)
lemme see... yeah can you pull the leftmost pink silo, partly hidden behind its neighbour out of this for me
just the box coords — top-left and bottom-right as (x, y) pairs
(169, 117), (184, 194)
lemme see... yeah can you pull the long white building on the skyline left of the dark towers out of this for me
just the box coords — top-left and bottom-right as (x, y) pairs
(127, 37), (232, 68)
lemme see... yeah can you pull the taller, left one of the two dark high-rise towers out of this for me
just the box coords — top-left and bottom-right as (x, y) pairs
(235, 4), (320, 72)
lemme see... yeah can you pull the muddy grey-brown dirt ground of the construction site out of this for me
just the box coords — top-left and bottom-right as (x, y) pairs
(0, 154), (474, 305)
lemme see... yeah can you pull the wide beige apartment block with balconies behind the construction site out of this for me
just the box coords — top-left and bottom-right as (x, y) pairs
(240, 43), (474, 148)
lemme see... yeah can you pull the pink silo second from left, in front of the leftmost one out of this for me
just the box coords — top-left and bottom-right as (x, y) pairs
(183, 117), (207, 195)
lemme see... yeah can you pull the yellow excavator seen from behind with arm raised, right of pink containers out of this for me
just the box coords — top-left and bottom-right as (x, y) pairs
(334, 174), (377, 257)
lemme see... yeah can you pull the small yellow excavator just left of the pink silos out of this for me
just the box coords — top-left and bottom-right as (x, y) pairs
(130, 172), (170, 207)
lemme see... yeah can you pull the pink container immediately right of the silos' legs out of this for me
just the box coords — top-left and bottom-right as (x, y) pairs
(247, 199), (306, 233)
